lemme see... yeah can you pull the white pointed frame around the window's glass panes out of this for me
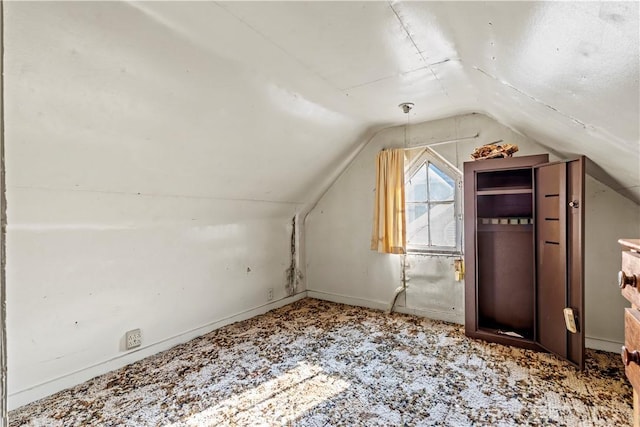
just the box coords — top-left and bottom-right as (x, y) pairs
(404, 147), (462, 255)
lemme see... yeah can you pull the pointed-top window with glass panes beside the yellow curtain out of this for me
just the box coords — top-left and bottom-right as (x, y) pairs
(405, 148), (462, 253)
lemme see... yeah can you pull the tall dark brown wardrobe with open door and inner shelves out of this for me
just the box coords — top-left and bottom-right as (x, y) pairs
(464, 154), (585, 369)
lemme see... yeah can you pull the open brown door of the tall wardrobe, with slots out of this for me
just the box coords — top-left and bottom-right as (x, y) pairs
(535, 157), (584, 369)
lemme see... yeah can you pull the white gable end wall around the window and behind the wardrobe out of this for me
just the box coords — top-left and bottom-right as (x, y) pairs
(305, 114), (640, 351)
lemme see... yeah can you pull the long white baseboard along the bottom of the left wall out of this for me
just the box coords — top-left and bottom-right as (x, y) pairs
(7, 291), (307, 411)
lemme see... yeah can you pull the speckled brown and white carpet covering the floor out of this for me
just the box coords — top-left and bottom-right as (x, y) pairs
(9, 299), (632, 427)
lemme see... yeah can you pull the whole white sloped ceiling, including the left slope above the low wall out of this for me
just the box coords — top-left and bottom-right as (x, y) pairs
(5, 2), (640, 203)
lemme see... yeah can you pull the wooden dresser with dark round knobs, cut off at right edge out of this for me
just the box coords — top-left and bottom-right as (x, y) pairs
(618, 239), (640, 427)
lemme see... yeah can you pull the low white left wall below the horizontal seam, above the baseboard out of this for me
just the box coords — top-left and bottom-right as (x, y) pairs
(7, 193), (302, 407)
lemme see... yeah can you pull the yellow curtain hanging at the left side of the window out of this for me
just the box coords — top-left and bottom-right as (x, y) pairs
(371, 149), (407, 254)
